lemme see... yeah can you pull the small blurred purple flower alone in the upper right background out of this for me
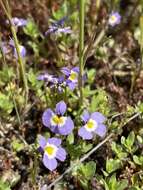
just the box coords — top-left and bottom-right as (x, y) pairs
(108, 12), (121, 26)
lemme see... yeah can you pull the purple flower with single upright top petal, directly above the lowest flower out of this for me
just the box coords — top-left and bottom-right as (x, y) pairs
(42, 101), (74, 135)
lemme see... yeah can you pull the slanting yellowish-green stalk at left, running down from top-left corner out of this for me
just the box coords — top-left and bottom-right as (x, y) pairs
(0, 0), (28, 104)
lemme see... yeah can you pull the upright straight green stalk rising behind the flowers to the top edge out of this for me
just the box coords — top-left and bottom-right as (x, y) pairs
(79, 0), (85, 105)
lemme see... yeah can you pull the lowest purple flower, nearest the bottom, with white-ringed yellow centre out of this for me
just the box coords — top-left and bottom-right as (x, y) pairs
(39, 136), (67, 171)
